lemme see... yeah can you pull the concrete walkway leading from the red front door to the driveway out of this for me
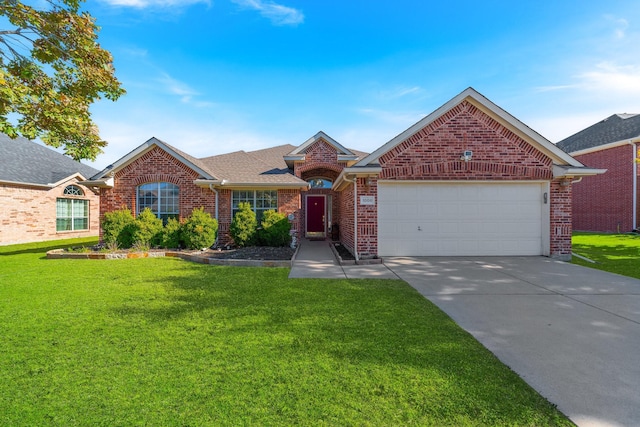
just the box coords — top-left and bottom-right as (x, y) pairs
(289, 240), (399, 279)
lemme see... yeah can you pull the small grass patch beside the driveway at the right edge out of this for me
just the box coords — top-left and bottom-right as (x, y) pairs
(572, 233), (640, 279)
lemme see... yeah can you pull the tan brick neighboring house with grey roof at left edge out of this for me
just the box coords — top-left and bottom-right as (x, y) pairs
(0, 134), (100, 245)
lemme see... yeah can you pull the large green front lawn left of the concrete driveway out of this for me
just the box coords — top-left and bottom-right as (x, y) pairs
(0, 241), (571, 426)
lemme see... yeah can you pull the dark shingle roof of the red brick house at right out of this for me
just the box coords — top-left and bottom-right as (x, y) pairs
(556, 114), (640, 153)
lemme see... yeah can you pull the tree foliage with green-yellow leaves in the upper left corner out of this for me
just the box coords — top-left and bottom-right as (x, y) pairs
(0, 0), (124, 160)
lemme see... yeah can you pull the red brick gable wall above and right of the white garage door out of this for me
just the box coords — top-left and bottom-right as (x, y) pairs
(370, 101), (571, 257)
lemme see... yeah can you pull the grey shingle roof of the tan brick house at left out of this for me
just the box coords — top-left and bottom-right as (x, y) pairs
(0, 133), (98, 186)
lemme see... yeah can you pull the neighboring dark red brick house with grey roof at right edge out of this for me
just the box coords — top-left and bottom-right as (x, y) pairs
(557, 114), (640, 233)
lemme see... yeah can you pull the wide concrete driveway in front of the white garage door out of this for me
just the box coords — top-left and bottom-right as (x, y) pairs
(385, 257), (640, 426)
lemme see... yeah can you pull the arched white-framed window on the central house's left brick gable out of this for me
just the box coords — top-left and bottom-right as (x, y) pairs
(136, 182), (180, 222)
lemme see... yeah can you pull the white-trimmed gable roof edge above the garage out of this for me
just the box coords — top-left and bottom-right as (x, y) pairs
(354, 87), (584, 168)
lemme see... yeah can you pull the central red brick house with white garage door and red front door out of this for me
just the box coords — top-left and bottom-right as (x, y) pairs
(84, 88), (602, 258)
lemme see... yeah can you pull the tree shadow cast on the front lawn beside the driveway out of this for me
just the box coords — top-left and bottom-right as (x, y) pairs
(109, 266), (562, 425)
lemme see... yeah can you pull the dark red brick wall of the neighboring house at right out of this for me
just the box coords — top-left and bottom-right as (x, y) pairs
(573, 145), (640, 233)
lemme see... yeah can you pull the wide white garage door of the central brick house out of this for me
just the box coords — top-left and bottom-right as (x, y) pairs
(378, 182), (549, 256)
